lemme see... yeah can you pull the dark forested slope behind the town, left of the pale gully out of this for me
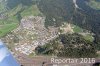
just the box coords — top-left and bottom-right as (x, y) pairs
(38, 0), (74, 27)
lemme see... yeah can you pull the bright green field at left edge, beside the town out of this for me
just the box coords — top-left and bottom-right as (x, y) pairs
(0, 13), (19, 37)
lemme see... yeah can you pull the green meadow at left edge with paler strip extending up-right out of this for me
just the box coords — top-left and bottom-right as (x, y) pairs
(0, 5), (21, 37)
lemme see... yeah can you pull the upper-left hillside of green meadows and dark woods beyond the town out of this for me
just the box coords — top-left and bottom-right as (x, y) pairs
(0, 0), (41, 37)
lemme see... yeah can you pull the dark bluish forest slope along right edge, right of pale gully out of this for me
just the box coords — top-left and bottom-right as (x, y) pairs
(72, 0), (100, 51)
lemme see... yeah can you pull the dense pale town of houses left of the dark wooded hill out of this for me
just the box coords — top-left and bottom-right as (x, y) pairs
(1, 16), (58, 55)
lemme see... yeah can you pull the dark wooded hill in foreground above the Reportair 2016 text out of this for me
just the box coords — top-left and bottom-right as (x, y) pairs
(36, 33), (97, 58)
